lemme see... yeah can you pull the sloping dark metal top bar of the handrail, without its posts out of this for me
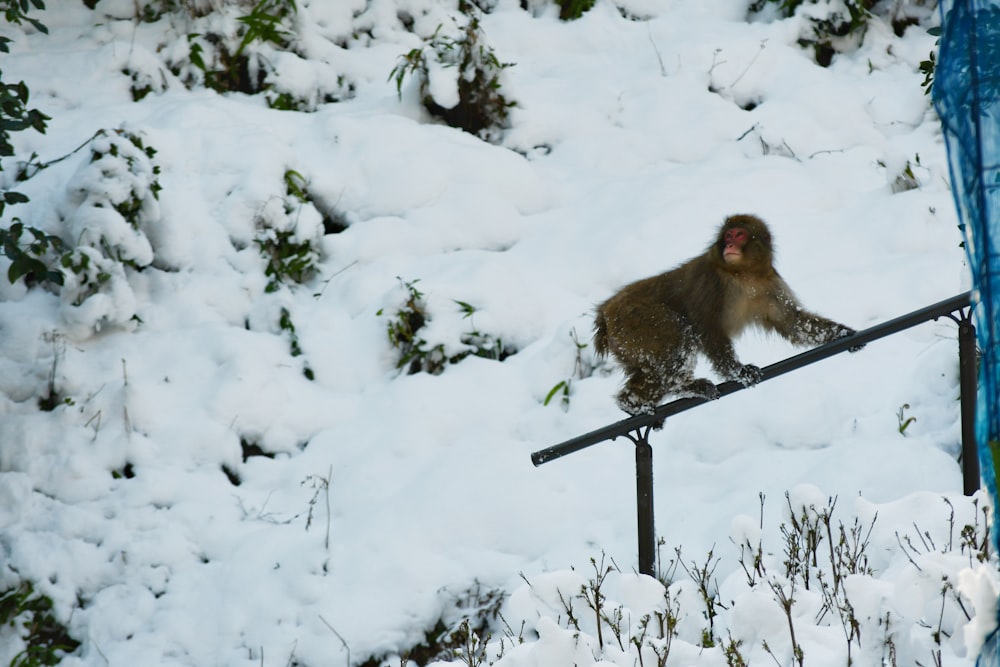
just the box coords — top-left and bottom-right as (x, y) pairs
(531, 292), (971, 466)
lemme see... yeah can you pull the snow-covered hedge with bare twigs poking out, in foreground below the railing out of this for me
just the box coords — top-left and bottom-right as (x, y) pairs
(417, 486), (996, 667)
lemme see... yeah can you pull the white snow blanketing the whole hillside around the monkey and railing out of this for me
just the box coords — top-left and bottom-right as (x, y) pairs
(0, 0), (988, 667)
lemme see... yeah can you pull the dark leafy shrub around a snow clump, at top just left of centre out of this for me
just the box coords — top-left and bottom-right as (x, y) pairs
(389, 4), (516, 142)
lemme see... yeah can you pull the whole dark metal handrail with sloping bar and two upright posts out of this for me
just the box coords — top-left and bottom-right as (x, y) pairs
(531, 292), (980, 575)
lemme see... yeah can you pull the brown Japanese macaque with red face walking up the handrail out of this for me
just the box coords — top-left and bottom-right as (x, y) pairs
(594, 215), (854, 415)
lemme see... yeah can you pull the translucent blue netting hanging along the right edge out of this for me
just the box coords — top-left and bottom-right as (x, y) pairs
(932, 0), (1000, 667)
